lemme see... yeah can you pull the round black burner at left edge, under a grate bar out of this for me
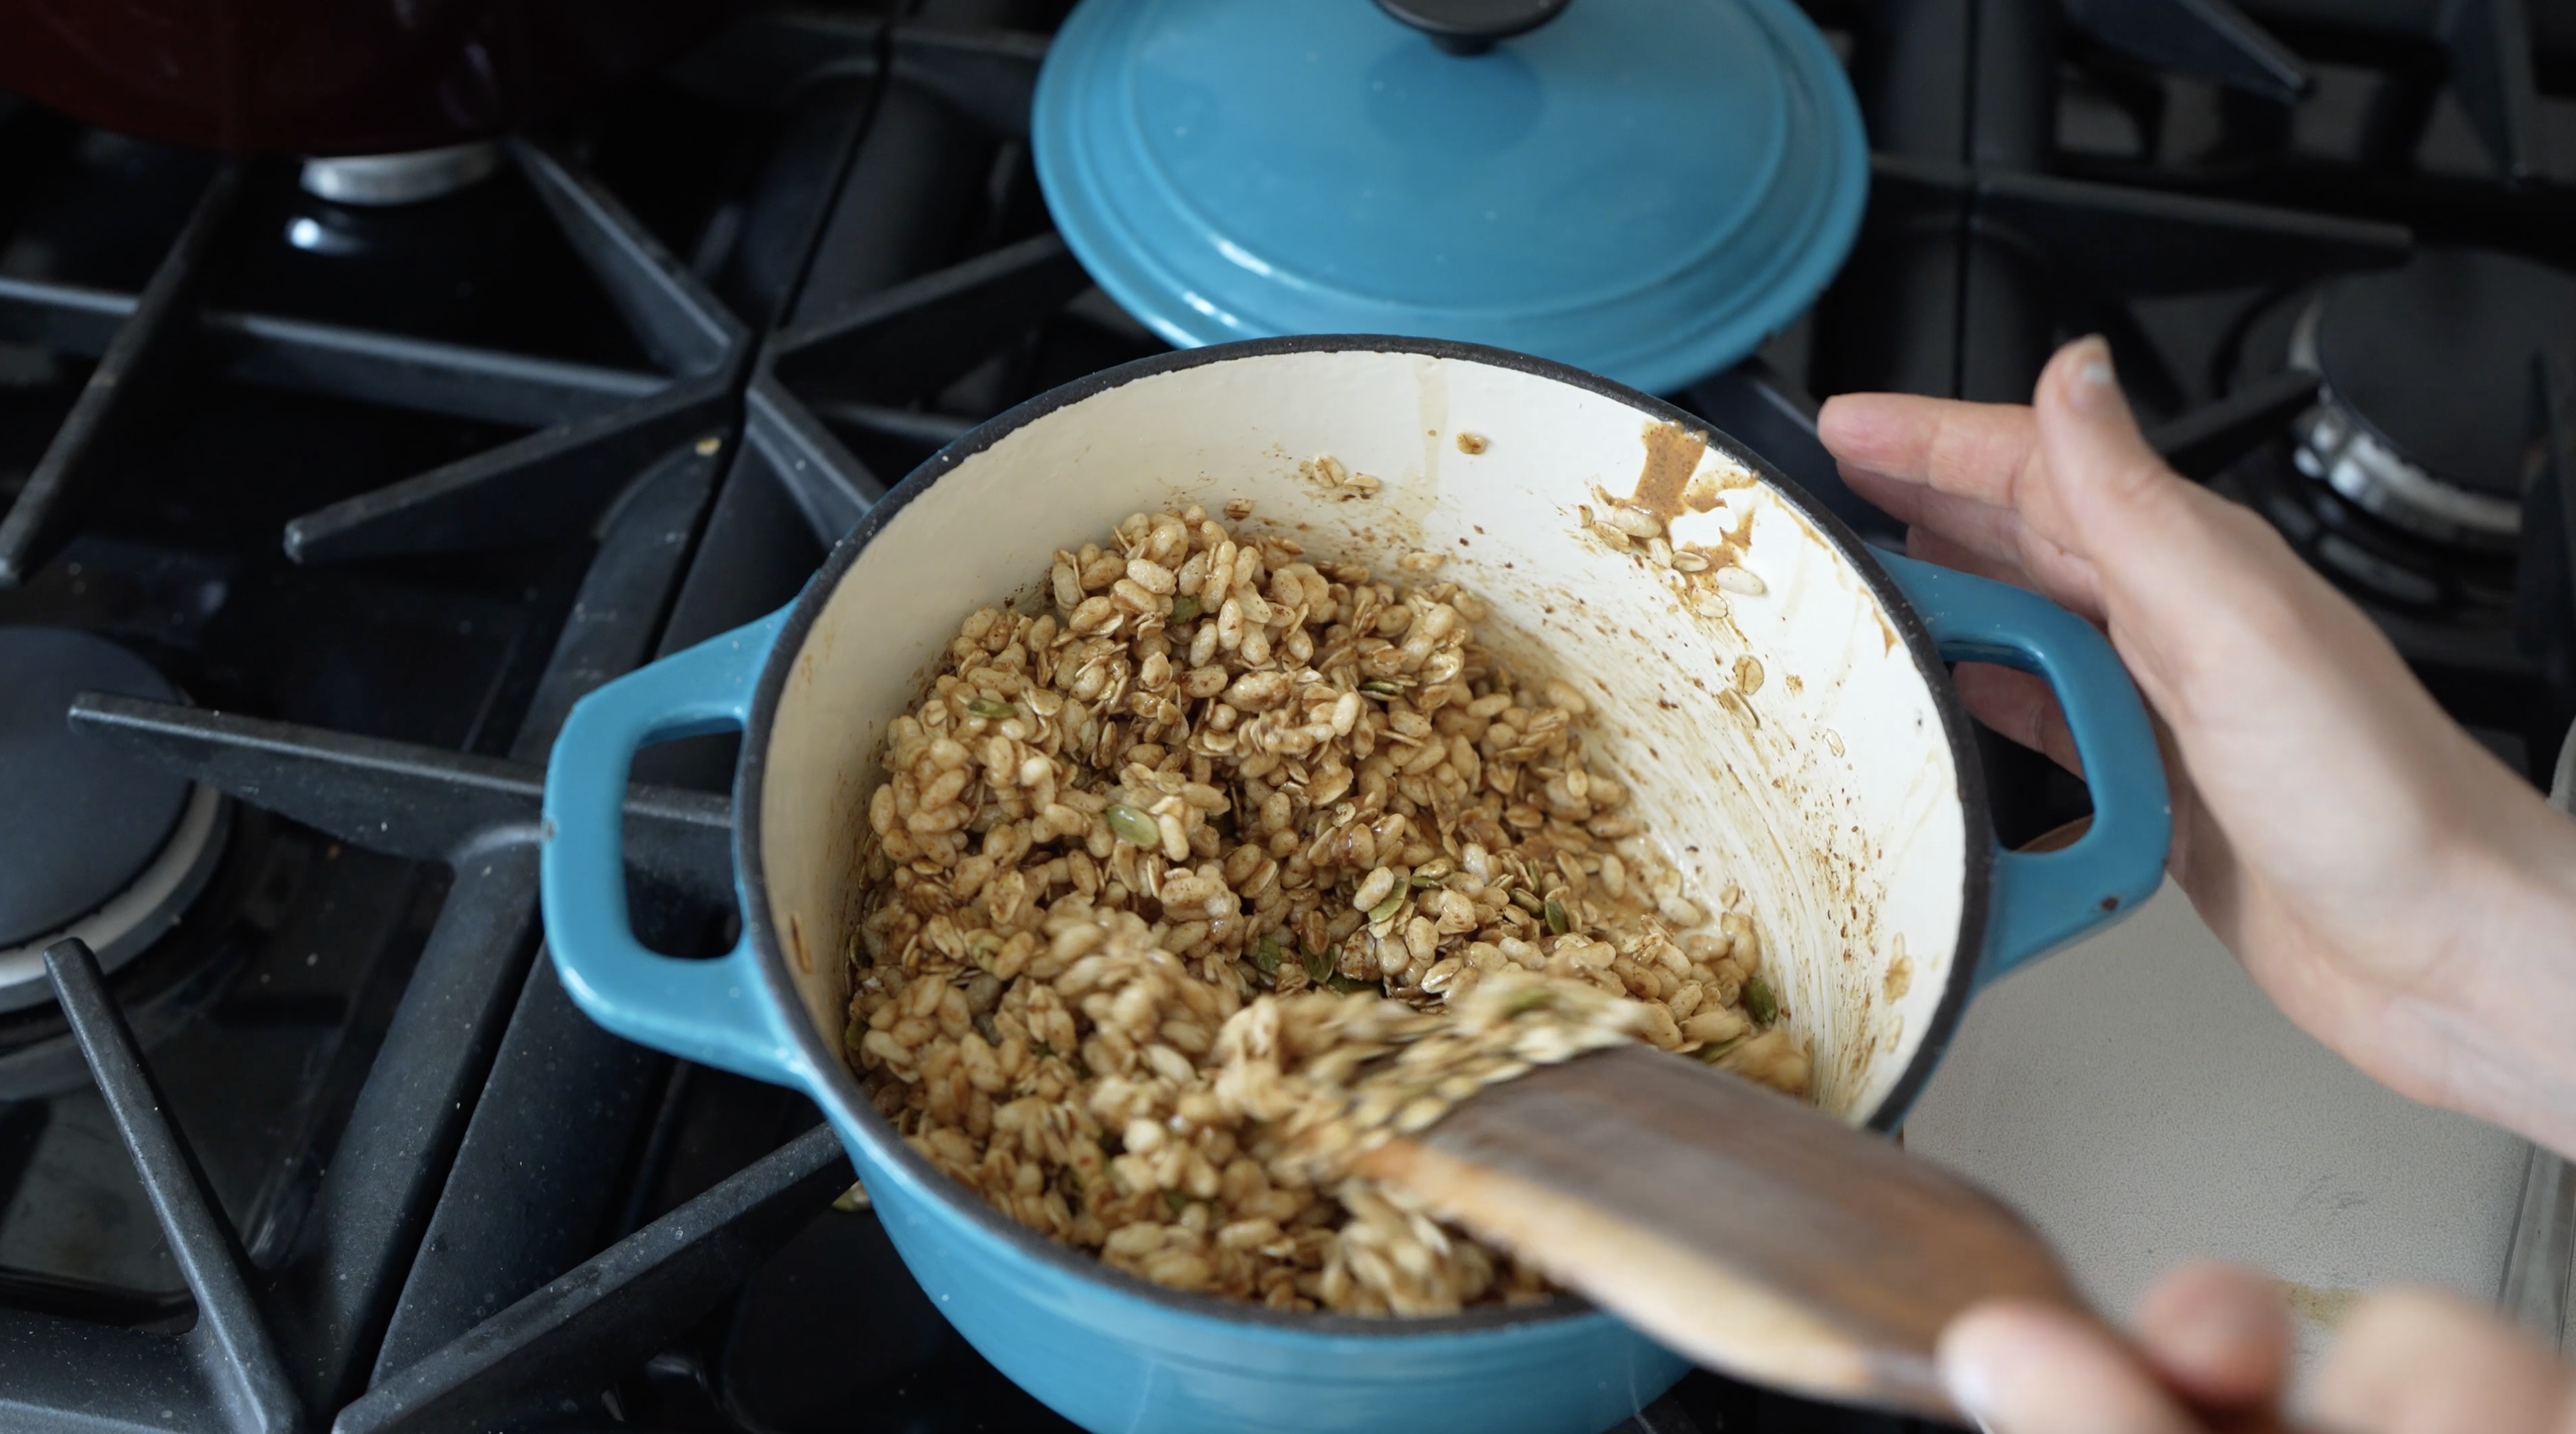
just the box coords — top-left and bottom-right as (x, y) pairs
(0, 628), (224, 1012)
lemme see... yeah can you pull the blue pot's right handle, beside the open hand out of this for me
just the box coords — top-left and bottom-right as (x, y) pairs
(1875, 553), (2174, 986)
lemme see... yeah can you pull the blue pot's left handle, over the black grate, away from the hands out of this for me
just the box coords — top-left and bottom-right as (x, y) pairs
(538, 608), (807, 1089)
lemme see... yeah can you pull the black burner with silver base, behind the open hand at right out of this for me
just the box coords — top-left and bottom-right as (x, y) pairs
(2290, 250), (2576, 549)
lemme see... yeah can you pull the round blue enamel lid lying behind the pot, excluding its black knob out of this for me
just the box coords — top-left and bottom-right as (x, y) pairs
(1033, 0), (1868, 391)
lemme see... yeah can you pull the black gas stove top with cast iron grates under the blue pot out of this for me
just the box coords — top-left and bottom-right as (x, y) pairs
(0, 0), (2576, 1434)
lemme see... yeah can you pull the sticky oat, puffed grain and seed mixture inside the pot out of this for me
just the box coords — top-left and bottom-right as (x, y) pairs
(847, 502), (1808, 1316)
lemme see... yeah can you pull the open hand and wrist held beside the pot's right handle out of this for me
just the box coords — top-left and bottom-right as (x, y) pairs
(1819, 340), (2576, 1154)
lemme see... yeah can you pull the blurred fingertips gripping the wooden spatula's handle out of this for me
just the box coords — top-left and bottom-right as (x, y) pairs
(1940, 1264), (2576, 1434)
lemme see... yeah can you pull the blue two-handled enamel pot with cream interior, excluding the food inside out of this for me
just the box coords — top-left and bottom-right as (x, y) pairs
(544, 337), (2169, 1434)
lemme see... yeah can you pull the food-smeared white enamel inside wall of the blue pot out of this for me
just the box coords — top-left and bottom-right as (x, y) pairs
(757, 340), (1986, 1122)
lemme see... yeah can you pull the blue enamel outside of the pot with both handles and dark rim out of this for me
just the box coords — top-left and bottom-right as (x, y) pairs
(544, 337), (2169, 1434)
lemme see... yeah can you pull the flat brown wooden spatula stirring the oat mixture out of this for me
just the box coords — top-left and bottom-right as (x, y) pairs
(1357, 1045), (2280, 1434)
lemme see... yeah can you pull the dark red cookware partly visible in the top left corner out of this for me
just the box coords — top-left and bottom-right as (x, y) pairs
(0, 0), (729, 155)
